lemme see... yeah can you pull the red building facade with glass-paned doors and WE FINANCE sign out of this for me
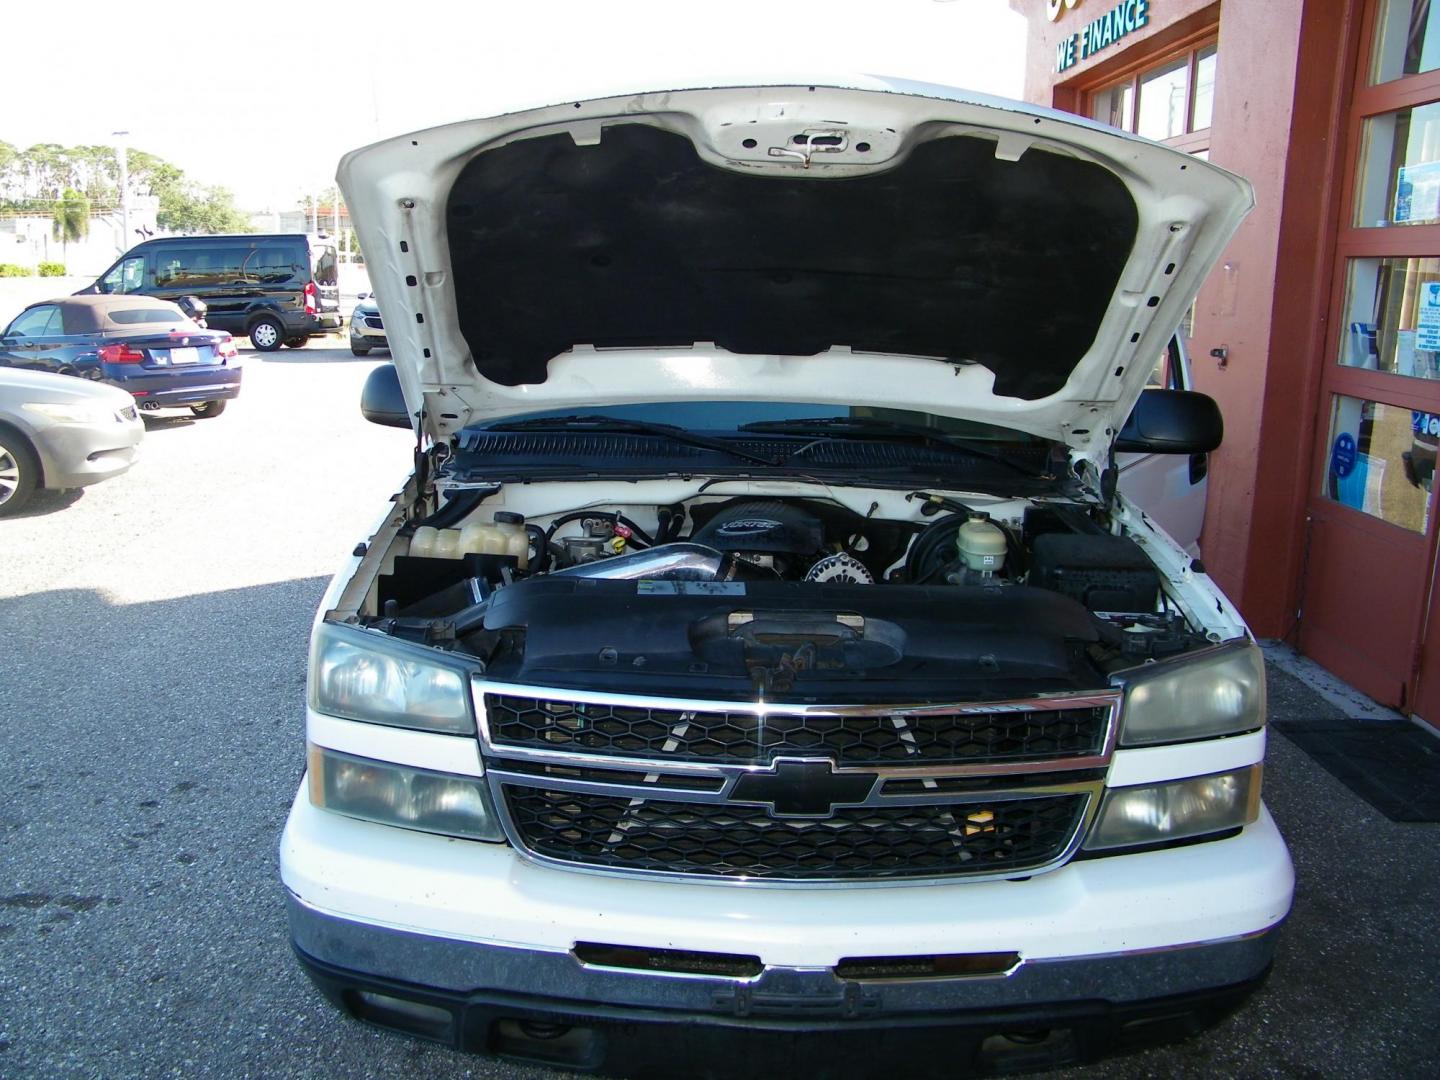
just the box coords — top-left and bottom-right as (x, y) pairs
(1011, 0), (1440, 723)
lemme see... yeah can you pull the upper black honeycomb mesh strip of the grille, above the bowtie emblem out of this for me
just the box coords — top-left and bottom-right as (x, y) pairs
(485, 694), (1107, 765)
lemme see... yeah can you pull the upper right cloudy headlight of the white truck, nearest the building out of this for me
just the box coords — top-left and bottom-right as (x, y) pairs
(1115, 642), (1264, 746)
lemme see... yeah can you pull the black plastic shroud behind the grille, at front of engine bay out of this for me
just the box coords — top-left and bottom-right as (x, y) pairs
(465, 577), (1106, 703)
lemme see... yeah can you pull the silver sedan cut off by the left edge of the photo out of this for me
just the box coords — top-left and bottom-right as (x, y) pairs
(0, 367), (145, 516)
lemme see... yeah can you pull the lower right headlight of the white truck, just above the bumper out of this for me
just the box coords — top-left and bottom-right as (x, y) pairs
(1084, 765), (1260, 851)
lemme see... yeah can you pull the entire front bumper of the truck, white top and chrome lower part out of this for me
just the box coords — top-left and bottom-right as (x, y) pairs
(281, 789), (1293, 1074)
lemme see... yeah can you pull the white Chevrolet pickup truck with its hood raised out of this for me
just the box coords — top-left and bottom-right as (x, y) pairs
(281, 81), (1293, 1074)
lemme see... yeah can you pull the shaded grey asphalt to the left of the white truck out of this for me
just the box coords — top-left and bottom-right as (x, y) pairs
(0, 577), (348, 1076)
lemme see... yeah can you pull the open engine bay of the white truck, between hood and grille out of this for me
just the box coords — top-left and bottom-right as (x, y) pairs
(339, 484), (1220, 701)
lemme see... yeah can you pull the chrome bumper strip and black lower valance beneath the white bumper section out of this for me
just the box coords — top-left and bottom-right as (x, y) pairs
(288, 896), (1276, 1076)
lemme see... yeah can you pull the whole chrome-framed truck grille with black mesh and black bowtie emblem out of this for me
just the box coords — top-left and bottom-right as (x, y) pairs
(475, 680), (1119, 884)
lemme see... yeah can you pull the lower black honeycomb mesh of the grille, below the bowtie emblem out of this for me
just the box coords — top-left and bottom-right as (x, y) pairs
(503, 785), (1086, 881)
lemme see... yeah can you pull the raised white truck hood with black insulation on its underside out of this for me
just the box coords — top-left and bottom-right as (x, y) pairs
(338, 79), (1253, 461)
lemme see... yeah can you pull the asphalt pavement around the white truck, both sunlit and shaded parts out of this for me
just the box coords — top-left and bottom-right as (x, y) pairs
(0, 340), (1440, 1080)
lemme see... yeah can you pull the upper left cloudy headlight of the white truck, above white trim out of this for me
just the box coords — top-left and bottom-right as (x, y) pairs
(310, 622), (475, 734)
